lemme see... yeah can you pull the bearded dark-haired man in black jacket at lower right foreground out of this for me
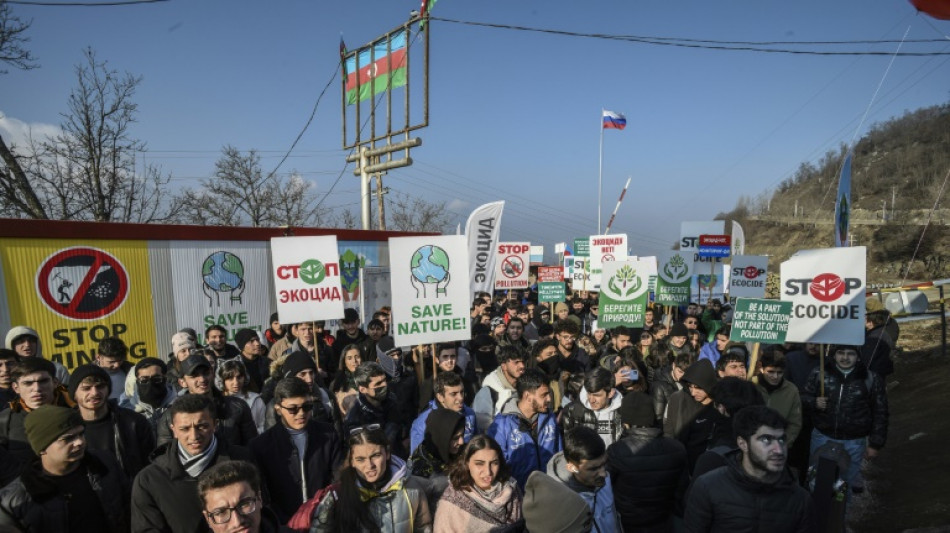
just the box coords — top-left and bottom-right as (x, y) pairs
(685, 405), (817, 533)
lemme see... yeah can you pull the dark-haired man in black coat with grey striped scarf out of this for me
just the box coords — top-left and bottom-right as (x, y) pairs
(132, 394), (251, 533)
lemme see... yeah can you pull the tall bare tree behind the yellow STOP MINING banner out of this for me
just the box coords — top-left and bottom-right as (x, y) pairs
(0, 49), (177, 223)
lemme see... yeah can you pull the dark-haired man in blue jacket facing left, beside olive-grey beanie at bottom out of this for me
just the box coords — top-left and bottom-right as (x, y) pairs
(547, 426), (620, 533)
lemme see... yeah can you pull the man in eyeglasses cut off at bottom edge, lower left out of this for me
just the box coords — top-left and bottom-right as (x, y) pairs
(198, 461), (283, 533)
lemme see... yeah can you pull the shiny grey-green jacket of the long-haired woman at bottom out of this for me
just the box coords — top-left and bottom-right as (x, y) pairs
(310, 456), (432, 533)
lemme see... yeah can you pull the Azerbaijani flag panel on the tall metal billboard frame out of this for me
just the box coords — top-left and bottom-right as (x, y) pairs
(344, 30), (406, 105)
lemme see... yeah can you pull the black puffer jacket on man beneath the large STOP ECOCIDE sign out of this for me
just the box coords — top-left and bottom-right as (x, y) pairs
(802, 363), (888, 450)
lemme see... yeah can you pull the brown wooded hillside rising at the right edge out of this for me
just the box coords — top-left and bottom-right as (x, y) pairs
(716, 103), (950, 287)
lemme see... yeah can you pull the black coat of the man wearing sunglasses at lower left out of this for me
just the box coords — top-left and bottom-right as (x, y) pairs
(248, 420), (343, 523)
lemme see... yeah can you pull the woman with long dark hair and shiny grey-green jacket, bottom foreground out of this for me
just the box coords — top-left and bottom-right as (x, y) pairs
(310, 424), (432, 533)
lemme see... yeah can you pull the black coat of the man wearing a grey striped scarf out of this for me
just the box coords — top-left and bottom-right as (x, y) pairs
(132, 439), (252, 533)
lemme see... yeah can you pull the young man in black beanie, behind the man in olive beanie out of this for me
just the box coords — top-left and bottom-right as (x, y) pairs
(69, 365), (155, 479)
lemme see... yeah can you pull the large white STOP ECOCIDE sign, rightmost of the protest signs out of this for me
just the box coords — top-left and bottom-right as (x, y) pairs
(781, 246), (867, 345)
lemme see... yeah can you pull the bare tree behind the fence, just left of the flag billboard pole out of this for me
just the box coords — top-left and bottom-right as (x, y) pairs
(176, 146), (327, 227)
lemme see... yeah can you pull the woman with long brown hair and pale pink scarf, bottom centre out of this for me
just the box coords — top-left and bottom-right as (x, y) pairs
(435, 435), (524, 533)
